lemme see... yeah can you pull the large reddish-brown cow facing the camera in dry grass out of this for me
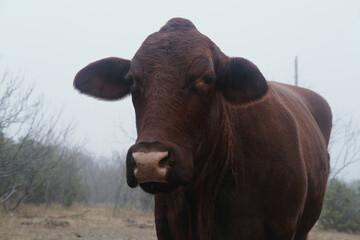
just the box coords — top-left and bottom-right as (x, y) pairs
(74, 18), (332, 240)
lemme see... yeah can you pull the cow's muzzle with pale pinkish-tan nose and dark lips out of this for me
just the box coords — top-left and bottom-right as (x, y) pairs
(126, 142), (192, 193)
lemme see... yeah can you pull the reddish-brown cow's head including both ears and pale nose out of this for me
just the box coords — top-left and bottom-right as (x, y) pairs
(74, 18), (267, 193)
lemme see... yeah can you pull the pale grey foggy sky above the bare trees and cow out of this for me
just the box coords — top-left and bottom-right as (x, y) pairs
(0, 0), (360, 178)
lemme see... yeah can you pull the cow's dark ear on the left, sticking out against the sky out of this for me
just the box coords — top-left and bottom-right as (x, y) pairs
(74, 57), (132, 100)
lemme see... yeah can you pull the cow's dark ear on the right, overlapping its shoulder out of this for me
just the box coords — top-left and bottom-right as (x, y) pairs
(216, 58), (268, 104)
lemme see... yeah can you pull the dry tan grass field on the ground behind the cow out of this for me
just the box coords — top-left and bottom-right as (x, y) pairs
(0, 205), (360, 240)
